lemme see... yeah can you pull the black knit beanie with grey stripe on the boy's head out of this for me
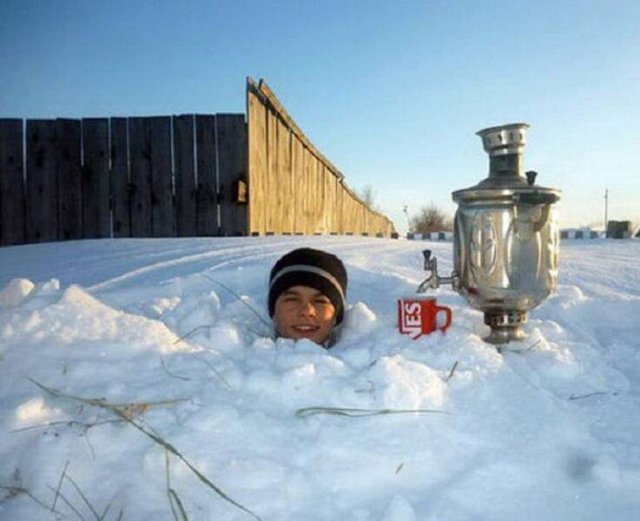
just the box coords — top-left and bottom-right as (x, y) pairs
(269, 248), (347, 325)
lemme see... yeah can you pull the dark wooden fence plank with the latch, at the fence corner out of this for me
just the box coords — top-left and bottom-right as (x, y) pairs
(216, 114), (247, 236)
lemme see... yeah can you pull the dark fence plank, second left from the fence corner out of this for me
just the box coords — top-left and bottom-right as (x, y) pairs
(196, 116), (219, 237)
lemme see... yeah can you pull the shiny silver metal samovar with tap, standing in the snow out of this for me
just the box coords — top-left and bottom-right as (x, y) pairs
(418, 123), (560, 344)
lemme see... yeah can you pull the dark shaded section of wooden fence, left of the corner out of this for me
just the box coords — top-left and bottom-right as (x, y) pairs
(0, 114), (247, 245)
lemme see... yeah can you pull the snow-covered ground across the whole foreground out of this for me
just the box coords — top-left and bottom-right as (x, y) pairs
(0, 237), (640, 521)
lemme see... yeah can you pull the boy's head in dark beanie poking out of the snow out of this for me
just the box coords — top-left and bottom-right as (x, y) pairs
(269, 248), (347, 348)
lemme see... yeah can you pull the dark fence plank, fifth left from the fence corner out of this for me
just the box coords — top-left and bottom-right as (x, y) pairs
(129, 118), (153, 237)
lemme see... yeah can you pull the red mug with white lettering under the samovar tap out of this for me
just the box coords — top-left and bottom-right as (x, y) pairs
(398, 296), (451, 340)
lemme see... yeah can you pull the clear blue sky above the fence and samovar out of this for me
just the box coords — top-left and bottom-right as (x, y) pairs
(0, 0), (640, 232)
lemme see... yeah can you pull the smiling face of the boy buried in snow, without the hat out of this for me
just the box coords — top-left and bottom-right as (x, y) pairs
(273, 286), (336, 344)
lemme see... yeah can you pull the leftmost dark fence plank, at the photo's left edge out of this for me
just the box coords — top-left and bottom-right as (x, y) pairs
(0, 119), (26, 246)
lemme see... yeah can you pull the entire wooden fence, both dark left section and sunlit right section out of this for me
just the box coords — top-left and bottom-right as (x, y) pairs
(0, 79), (397, 246)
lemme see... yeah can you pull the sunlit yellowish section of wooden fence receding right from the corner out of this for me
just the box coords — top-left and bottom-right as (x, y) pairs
(247, 79), (395, 237)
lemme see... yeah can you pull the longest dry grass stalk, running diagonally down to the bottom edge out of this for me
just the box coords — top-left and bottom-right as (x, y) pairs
(29, 379), (261, 521)
